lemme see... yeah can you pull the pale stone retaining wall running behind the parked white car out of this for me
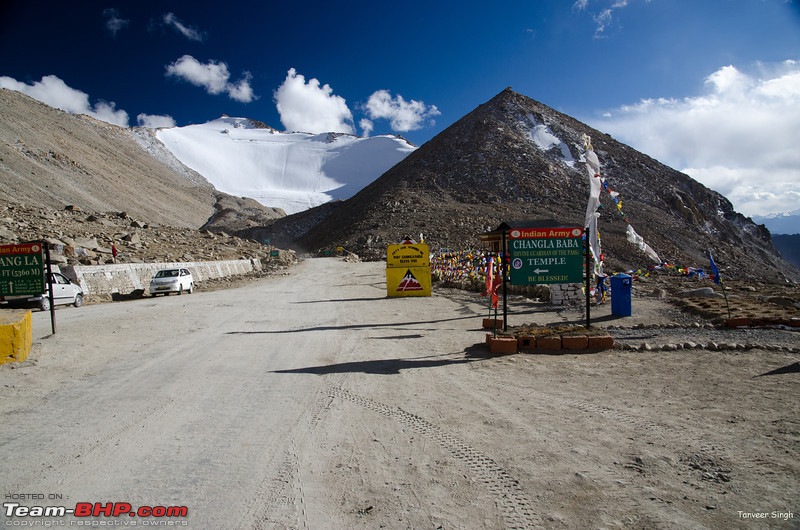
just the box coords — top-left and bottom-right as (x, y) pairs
(60, 259), (261, 296)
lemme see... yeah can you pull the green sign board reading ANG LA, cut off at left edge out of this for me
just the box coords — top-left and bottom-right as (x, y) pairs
(0, 243), (45, 296)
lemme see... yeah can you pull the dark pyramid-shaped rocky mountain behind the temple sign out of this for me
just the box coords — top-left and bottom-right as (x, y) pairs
(260, 88), (800, 282)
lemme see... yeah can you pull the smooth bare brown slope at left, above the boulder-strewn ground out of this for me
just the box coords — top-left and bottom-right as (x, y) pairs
(0, 89), (283, 230)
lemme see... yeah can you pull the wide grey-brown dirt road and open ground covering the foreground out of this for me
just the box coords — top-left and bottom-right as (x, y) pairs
(0, 258), (800, 529)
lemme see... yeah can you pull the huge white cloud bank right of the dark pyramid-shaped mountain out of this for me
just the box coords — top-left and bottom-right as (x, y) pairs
(593, 61), (800, 216)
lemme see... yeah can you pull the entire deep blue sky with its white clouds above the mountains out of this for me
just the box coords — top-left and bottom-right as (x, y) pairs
(0, 0), (800, 215)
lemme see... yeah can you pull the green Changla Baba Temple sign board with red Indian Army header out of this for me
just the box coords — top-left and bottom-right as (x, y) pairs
(508, 227), (584, 285)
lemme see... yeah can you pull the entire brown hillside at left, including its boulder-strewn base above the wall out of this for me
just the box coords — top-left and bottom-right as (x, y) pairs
(0, 89), (292, 270)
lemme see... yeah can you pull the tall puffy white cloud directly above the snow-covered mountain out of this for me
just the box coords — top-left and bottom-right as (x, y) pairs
(275, 68), (355, 134)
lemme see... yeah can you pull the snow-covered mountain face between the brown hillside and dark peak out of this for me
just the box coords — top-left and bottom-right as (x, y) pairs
(157, 116), (416, 214)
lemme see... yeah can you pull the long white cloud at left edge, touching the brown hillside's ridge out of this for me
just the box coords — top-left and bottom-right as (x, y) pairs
(0, 75), (128, 127)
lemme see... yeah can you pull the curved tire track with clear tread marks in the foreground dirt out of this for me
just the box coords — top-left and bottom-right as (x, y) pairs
(328, 387), (543, 529)
